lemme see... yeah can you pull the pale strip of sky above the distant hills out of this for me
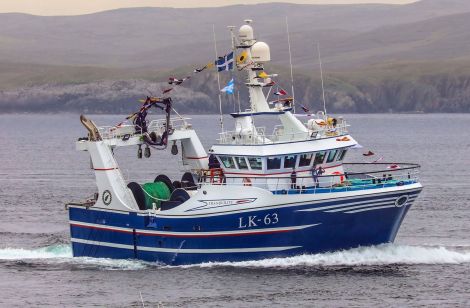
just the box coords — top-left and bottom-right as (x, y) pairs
(0, 0), (415, 15)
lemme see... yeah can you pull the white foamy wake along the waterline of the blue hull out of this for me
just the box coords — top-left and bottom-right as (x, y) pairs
(0, 244), (470, 270)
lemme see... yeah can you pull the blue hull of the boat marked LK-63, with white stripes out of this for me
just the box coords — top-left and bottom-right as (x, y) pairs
(69, 189), (421, 265)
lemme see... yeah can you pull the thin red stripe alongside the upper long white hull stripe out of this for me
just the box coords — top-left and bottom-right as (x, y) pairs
(70, 223), (304, 238)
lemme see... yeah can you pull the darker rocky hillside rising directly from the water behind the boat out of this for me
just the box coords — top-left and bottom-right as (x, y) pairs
(0, 60), (470, 113)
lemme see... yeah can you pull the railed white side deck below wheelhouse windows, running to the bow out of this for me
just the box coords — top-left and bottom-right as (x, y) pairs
(198, 163), (420, 194)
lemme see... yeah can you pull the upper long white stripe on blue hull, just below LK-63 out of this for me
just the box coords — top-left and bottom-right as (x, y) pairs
(70, 220), (320, 237)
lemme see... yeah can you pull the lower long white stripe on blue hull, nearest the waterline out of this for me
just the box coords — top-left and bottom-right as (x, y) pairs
(71, 238), (302, 254)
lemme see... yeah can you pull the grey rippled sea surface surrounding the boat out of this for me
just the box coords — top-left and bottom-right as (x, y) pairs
(0, 114), (470, 307)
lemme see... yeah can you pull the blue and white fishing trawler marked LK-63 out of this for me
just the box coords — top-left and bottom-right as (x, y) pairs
(67, 21), (422, 265)
